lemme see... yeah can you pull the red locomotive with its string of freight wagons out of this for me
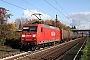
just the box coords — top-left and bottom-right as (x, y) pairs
(20, 24), (78, 50)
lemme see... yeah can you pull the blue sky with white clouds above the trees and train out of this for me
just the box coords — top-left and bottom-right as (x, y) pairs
(0, 0), (90, 29)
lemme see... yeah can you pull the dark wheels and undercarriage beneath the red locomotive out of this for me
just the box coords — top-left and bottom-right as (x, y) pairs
(20, 41), (60, 51)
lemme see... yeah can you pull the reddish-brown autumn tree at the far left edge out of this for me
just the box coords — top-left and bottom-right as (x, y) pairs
(0, 7), (12, 45)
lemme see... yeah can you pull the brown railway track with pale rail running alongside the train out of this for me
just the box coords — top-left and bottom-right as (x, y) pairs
(0, 38), (82, 60)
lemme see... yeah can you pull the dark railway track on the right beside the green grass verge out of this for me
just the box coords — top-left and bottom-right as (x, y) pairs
(56, 38), (86, 60)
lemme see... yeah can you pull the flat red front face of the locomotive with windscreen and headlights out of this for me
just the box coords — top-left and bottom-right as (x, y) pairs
(21, 26), (37, 42)
